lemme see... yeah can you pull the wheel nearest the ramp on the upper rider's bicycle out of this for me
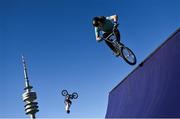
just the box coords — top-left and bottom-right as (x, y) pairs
(121, 46), (136, 65)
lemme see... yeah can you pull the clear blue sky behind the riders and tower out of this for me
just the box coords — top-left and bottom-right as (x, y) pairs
(0, 0), (180, 118)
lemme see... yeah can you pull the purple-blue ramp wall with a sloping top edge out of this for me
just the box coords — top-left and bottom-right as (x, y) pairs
(106, 29), (180, 118)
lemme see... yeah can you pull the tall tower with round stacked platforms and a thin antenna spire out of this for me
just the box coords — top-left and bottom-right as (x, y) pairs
(22, 56), (39, 119)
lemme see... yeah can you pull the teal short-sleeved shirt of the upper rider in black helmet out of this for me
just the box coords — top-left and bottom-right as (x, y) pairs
(95, 17), (114, 36)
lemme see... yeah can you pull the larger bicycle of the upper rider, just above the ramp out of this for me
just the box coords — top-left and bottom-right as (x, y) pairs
(104, 24), (137, 65)
